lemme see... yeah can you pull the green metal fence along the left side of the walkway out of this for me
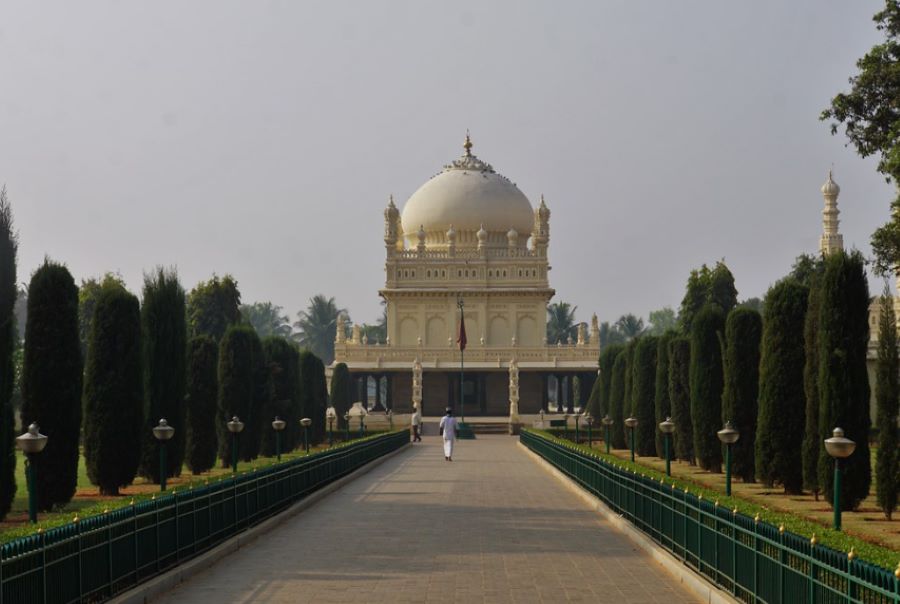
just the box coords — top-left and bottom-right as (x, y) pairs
(0, 432), (409, 604)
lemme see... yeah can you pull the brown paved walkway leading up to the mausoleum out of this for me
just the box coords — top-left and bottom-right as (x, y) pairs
(161, 436), (697, 604)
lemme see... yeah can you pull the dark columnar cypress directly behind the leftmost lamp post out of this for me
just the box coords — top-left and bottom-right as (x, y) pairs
(22, 260), (82, 511)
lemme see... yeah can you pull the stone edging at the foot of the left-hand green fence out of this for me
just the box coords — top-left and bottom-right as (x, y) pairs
(109, 443), (411, 604)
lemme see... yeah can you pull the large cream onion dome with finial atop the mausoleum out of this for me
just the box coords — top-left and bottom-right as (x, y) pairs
(401, 137), (534, 245)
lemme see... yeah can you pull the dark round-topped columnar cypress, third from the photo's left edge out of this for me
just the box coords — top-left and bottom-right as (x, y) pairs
(83, 286), (143, 495)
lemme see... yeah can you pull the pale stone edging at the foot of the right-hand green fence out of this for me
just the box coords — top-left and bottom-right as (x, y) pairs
(519, 442), (739, 604)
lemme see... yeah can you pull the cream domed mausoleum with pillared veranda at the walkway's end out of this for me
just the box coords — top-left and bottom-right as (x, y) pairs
(335, 136), (600, 423)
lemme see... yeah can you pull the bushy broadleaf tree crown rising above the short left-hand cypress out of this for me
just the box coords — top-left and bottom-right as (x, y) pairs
(187, 275), (241, 342)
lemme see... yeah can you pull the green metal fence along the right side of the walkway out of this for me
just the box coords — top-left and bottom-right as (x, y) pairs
(520, 431), (900, 604)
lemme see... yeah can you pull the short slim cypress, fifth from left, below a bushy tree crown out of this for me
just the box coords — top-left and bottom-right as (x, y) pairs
(185, 336), (219, 474)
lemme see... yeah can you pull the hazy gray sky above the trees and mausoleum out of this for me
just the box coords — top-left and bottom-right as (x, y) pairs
(0, 0), (892, 322)
